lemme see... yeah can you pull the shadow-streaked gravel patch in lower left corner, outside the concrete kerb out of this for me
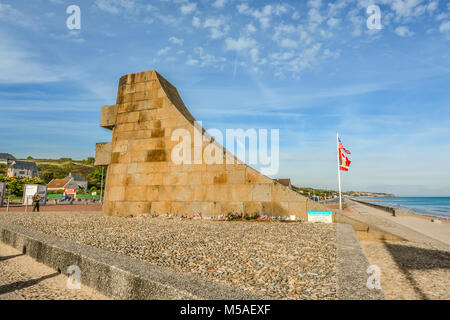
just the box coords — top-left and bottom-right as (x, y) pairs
(0, 242), (108, 300)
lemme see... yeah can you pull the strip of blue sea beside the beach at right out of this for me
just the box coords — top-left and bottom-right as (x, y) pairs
(362, 197), (450, 220)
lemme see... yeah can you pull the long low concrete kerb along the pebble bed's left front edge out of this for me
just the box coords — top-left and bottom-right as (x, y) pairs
(0, 223), (258, 300)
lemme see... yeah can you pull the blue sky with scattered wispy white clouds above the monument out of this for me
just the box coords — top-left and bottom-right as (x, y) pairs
(0, 0), (450, 196)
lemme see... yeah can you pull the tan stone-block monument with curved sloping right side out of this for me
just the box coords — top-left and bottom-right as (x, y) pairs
(96, 71), (326, 220)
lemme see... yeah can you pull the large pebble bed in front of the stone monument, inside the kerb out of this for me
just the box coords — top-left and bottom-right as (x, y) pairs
(0, 212), (337, 299)
